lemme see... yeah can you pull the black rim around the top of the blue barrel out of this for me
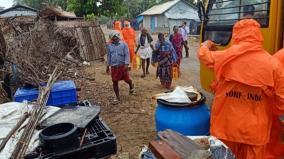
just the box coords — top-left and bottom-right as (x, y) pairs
(157, 92), (206, 107)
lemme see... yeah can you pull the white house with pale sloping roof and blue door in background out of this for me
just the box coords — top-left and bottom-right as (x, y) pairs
(140, 0), (200, 33)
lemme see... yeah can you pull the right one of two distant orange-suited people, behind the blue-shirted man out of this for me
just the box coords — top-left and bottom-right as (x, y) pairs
(122, 21), (136, 68)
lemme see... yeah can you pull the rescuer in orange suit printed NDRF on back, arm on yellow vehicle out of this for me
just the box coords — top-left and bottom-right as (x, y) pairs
(198, 19), (284, 159)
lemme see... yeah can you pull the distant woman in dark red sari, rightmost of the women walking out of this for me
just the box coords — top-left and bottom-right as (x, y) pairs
(170, 26), (184, 66)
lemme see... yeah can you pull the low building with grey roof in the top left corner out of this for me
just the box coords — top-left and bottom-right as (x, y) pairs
(0, 5), (38, 17)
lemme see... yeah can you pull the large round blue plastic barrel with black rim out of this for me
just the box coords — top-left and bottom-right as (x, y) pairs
(155, 95), (210, 136)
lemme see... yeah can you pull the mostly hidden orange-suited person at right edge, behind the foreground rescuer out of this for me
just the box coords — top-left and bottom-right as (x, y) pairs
(266, 49), (284, 159)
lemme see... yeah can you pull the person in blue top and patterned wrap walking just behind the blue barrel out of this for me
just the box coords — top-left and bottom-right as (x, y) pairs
(152, 33), (176, 89)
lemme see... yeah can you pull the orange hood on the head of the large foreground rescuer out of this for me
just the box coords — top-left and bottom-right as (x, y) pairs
(232, 19), (263, 45)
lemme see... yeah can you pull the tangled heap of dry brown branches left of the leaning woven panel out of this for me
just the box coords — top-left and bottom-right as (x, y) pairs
(6, 19), (83, 86)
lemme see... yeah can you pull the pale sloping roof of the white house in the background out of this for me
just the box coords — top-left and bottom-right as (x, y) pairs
(140, 0), (180, 15)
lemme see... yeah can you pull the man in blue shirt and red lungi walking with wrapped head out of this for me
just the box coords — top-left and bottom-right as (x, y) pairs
(106, 31), (134, 102)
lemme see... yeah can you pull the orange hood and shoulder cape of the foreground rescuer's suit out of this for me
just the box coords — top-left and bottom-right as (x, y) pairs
(214, 19), (274, 87)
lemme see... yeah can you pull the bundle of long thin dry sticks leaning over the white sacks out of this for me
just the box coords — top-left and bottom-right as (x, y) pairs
(10, 67), (62, 159)
